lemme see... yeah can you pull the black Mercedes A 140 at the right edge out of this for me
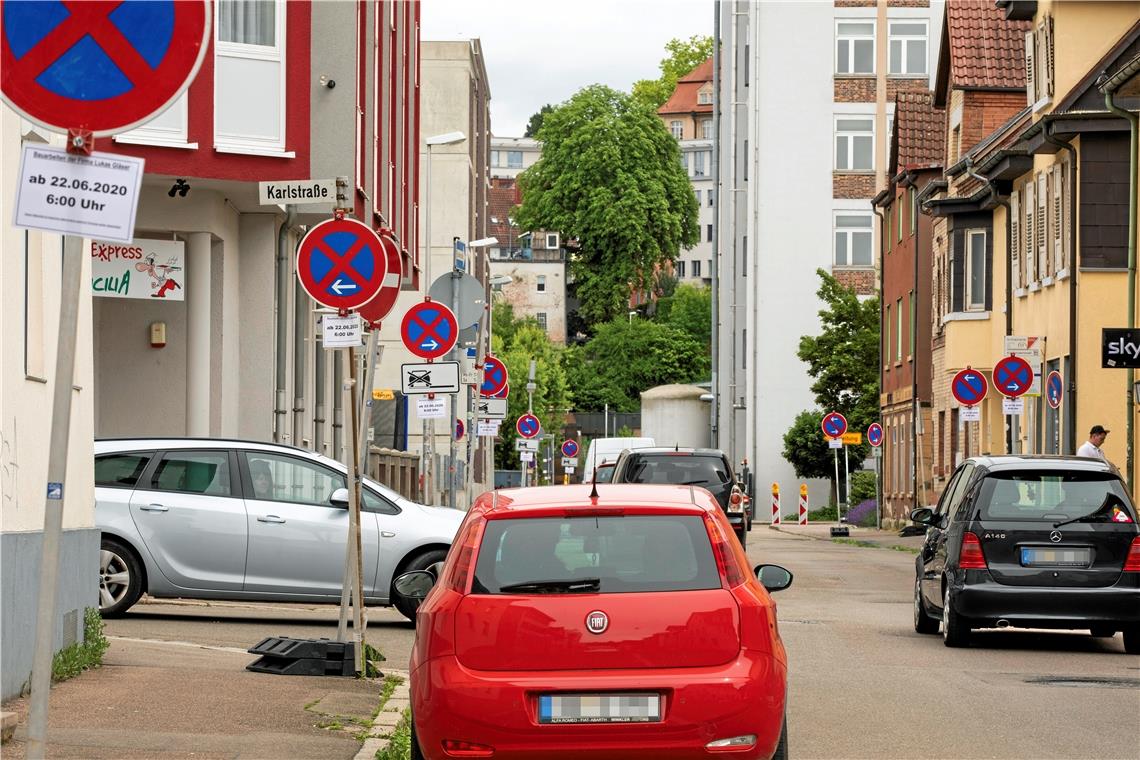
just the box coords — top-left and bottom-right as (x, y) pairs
(911, 456), (1140, 654)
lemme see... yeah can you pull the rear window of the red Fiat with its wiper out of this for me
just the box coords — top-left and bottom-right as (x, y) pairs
(472, 515), (720, 594)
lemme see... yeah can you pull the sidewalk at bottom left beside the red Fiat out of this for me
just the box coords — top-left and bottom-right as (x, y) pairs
(0, 638), (407, 760)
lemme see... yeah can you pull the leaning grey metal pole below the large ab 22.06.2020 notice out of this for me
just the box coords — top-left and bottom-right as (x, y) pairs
(27, 235), (83, 758)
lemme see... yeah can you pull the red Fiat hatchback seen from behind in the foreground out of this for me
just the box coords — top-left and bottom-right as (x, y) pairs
(397, 485), (791, 760)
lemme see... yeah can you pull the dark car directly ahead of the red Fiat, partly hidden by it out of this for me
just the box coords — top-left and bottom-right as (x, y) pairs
(612, 447), (752, 546)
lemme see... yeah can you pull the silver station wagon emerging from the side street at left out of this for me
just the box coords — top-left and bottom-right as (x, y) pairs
(95, 439), (463, 619)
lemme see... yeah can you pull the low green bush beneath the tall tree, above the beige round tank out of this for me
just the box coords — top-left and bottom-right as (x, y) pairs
(565, 319), (709, 411)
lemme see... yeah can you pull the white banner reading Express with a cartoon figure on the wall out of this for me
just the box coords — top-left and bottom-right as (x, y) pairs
(91, 240), (186, 301)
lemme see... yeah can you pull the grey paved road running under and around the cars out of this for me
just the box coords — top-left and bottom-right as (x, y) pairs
(107, 525), (1140, 760)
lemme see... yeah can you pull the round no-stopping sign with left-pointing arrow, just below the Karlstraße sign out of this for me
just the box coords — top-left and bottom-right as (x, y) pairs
(296, 219), (388, 309)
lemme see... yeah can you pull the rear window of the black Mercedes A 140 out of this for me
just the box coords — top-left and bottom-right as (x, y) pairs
(977, 469), (1135, 522)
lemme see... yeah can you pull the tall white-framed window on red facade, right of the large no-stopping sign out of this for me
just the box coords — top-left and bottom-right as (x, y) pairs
(214, 0), (286, 155)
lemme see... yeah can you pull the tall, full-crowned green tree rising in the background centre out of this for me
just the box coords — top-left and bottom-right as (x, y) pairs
(515, 84), (698, 322)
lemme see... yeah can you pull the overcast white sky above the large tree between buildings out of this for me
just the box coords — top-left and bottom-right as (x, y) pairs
(421, 0), (713, 137)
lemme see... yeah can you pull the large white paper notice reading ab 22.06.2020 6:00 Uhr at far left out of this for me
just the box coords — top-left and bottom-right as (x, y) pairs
(13, 144), (146, 243)
